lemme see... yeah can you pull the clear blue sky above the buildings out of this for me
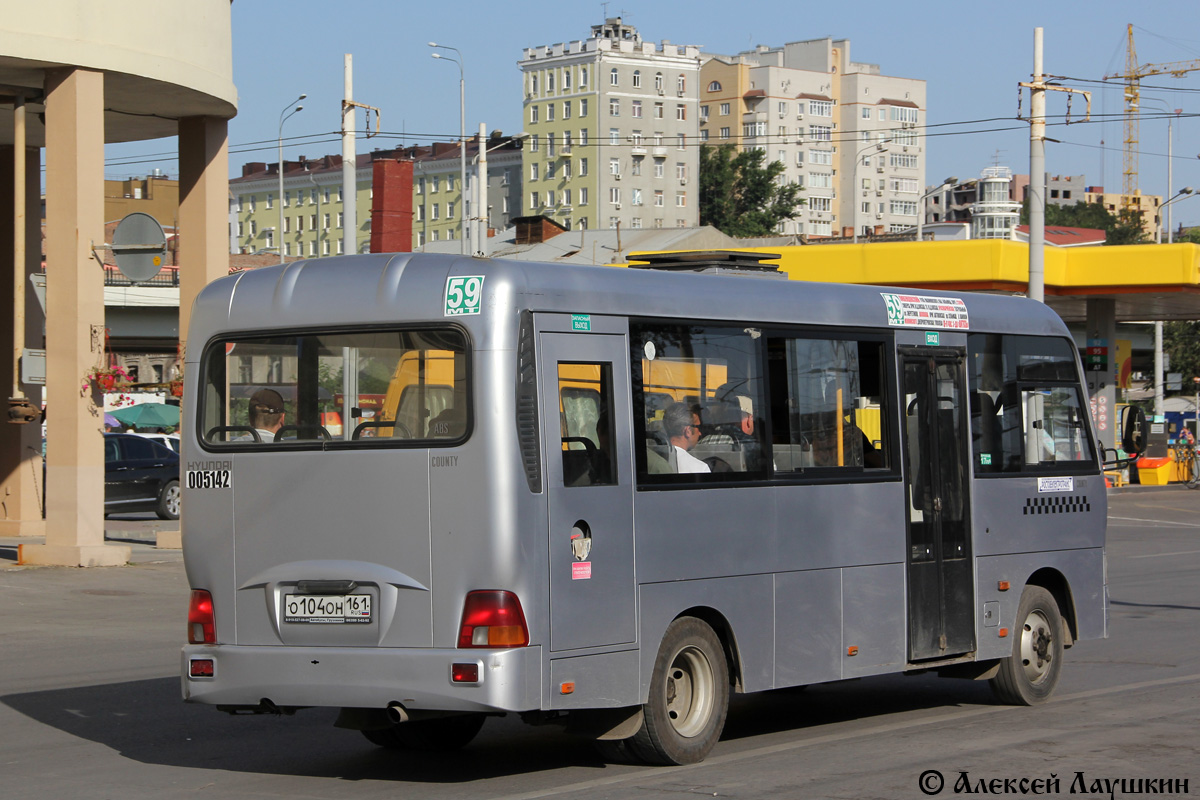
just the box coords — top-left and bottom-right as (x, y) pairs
(106, 0), (1200, 224)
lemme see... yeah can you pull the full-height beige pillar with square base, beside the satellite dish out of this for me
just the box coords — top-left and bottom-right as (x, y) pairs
(19, 68), (130, 566)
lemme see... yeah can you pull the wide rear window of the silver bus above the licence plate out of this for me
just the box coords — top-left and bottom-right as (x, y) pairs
(198, 329), (469, 447)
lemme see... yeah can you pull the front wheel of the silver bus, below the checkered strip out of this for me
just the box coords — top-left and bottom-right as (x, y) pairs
(991, 587), (1062, 705)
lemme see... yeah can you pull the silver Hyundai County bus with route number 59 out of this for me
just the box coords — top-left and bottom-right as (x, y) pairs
(181, 253), (1108, 764)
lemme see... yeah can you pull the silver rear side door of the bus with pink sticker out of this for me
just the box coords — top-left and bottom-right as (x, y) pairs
(539, 333), (636, 651)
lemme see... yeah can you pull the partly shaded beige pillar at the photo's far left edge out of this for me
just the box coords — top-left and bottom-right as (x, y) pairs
(0, 146), (46, 536)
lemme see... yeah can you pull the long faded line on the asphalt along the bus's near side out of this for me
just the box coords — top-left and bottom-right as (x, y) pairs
(482, 674), (1200, 800)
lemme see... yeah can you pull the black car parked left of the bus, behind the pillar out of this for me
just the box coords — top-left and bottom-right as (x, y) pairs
(104, 433), (181, 519)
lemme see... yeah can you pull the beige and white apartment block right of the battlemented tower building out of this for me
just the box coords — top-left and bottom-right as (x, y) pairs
(700, 38), (925, 237)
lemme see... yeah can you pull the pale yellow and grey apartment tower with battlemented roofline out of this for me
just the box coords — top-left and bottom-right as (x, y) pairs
(518, 17), (701, 229)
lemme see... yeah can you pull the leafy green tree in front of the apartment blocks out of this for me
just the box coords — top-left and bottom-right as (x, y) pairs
(700, 144), (804, 237)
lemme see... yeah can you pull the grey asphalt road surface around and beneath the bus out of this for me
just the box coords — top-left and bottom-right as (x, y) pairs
(0, 487), (1200, 799)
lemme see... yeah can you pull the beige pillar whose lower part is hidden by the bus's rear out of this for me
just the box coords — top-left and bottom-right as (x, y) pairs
(179, 116), (229, 359)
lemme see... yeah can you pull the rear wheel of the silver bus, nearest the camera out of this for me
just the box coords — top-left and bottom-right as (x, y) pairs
(629, 616), (730, 764)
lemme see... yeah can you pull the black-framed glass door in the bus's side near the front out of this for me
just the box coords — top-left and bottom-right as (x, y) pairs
(901, 348), (974, 661)
